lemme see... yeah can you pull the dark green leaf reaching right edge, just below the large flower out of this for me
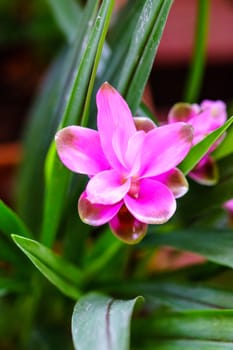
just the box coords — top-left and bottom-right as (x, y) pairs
(141, 228), (233, 268)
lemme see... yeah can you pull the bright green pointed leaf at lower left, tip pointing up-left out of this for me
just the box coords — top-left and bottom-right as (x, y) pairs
(12, 235), (83, 300)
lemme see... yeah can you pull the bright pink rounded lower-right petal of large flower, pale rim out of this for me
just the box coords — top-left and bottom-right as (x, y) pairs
(124, 179), (176, 224)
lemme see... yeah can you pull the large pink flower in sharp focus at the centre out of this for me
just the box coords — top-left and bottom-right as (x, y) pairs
(56, 83), (192, 243)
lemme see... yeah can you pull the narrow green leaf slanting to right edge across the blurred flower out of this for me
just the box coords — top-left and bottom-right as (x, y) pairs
(179, 117), (233, 174)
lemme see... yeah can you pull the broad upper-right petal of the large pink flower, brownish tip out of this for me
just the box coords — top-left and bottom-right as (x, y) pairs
(140, 122), (193, 177)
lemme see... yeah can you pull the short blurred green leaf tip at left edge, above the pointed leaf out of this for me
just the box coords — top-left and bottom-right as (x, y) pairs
(0, 200), (31, 237)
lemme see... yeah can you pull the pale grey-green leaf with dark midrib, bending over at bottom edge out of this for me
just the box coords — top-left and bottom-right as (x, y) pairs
(72, 293), (141, 350)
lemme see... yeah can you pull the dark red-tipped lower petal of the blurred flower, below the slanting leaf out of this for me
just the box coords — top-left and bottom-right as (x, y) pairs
(188, 155), (219, 186)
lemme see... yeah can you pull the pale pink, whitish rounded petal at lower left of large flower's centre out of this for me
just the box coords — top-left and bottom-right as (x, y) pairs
(86, 170), (130, 204)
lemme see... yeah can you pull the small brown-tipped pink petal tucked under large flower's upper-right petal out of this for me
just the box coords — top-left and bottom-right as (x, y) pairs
(154, 168), (189, 198)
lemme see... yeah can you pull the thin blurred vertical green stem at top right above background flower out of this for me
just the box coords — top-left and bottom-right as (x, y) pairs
(184, 0), (210, 102)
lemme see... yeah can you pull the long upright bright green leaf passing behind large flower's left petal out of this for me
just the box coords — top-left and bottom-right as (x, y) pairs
(42, 0), (114, 246)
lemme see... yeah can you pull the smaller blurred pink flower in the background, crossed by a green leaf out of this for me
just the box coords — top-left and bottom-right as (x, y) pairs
(168, 100), (227, 185)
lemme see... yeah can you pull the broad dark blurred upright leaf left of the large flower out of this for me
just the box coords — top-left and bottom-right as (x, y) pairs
(17, 0), (97, 233)
